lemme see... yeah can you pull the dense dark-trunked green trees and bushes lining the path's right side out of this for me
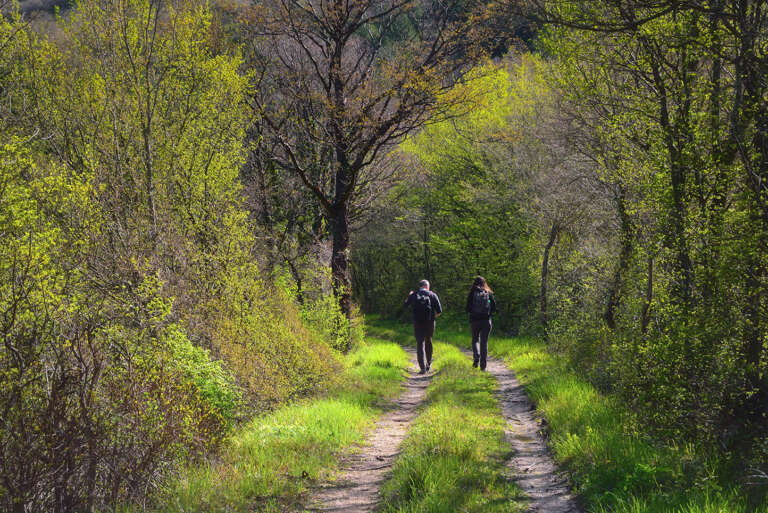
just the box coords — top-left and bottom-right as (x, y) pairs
(542, 2), (768, 462)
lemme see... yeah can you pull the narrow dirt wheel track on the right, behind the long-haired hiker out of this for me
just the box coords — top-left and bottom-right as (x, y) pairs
(487, 358), (580, 513)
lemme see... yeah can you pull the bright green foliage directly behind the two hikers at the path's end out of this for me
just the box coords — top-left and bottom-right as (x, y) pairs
(353, 61), (543, 328)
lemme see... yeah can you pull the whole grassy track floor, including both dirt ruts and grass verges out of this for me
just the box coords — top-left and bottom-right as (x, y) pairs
(118, 317), (768, 513)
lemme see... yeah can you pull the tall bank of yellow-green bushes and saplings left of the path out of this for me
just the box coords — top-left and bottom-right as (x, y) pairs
(0, 0), (339, 513)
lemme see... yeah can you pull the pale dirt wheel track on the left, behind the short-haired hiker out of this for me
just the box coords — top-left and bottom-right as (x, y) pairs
(309, 349), (434, 513)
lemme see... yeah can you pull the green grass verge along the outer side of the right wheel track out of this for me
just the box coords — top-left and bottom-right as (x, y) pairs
(369, 318), (768, 513)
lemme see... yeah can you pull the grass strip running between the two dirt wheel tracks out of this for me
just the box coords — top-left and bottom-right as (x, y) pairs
(376, 342), (525, 513)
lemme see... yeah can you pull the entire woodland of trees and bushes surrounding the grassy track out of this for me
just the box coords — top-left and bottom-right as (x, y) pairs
(0, 0), (768, 512)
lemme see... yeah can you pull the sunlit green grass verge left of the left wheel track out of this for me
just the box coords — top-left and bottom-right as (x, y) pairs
(142, 338), (408, 513)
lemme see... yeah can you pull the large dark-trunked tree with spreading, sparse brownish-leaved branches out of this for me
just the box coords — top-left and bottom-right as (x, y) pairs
(247, 0), (500, 316)
